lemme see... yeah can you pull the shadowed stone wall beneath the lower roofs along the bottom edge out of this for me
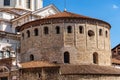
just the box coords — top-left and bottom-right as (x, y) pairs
(19, 68), (120, 80)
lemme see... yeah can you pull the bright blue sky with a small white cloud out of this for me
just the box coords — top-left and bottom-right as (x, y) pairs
(43, 0), (120, 48)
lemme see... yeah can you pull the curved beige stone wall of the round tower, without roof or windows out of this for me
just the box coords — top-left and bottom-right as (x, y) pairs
(21, 20), (111, 65)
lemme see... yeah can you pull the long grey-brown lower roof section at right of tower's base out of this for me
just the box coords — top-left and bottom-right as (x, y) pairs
(60, 65), (120, 75)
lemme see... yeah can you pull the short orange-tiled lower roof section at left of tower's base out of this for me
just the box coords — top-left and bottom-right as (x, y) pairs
(20, 61), (57, 68)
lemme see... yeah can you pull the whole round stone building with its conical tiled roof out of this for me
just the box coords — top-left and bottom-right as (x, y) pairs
(18, 11), (111, 66)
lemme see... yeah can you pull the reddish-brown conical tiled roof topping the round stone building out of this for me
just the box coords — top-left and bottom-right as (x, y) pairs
(18, 11), (111, 31)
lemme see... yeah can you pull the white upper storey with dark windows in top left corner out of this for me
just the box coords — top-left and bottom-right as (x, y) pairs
(0, 0), (43, 11)
